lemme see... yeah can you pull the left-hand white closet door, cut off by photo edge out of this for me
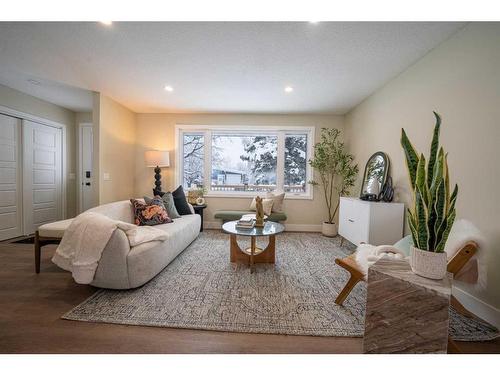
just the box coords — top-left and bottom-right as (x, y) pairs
(0, 114), (23, 240)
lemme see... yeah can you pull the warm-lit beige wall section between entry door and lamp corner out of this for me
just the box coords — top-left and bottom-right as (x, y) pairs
(98, 94), (136, 204)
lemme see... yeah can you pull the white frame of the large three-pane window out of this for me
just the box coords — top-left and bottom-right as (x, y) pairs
(175, 124), (315, 200)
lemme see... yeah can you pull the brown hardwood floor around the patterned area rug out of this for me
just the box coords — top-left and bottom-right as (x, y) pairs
(0, 243), (500, 353)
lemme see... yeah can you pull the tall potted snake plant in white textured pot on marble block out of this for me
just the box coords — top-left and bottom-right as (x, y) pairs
(401, 112), (458, 279)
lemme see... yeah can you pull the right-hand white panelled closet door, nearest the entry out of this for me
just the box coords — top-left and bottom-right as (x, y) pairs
(23, 120), (62, 234)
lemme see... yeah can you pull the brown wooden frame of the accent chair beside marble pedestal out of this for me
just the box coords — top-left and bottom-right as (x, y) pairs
(335, 242), (478, 305)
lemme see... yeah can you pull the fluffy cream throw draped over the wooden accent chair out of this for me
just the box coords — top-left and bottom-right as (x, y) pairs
(356, 219), (488, 289)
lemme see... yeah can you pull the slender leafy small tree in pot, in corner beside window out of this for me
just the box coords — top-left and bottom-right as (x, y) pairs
(309, 128), (358, 237)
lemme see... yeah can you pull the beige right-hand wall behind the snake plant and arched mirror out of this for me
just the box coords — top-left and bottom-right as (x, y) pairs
(346, 23), (500, 308)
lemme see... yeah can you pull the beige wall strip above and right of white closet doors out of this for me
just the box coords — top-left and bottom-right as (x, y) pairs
(0, 85), (76, 217)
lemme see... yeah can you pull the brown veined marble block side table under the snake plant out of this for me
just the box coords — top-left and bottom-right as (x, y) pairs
(363, 257), (453, 353)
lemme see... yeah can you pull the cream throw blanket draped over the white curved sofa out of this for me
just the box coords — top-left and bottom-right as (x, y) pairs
(52, 212), (167, 284)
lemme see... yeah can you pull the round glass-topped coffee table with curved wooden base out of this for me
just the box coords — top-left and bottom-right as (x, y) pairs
(222, 221), (285, 273)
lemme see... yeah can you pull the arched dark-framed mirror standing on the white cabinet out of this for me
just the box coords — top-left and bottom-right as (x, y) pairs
(360, 151), (389, 200)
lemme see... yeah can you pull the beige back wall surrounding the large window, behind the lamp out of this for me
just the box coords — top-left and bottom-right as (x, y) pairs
(135, 114), (343, 229)
